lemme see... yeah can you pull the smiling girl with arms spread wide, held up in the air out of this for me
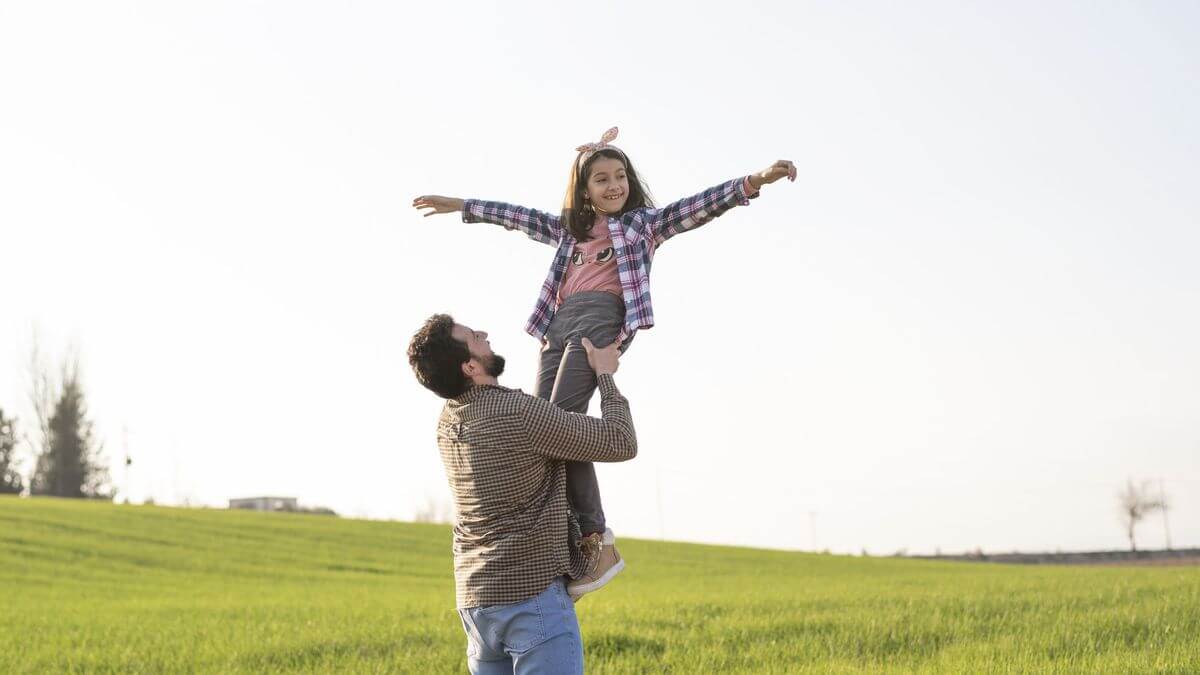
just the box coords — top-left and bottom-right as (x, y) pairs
(413, 127), (796, 599)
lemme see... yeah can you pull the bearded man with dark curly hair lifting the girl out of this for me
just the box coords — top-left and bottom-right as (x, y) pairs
(408, 315), (637, 674)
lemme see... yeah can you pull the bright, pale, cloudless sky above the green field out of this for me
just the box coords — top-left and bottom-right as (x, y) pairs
(0, 0), (1200, 554)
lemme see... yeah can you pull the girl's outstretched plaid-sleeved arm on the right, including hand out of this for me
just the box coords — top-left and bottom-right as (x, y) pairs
(646, 160), (796, 246)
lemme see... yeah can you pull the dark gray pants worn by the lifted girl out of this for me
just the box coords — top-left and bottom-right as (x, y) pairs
(533, 291), (634, 534)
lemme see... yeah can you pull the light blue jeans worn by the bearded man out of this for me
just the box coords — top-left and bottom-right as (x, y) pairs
(458, 577), (583, 675)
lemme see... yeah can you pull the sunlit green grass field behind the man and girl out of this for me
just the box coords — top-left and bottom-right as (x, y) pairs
(0, 497), (1200, 673)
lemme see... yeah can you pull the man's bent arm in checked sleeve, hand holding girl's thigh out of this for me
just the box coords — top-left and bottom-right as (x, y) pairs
(522, 338), (637, 461)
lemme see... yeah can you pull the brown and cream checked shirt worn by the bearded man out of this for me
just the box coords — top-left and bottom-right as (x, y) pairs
(438, 375), (637, 608)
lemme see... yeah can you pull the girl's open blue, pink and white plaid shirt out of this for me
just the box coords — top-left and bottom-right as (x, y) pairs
(462, 178), (757, 340)
